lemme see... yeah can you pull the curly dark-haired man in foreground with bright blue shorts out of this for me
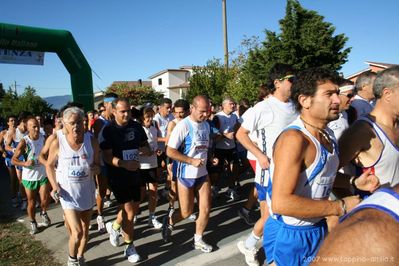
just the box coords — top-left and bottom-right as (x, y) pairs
(263, 68), (368, 265)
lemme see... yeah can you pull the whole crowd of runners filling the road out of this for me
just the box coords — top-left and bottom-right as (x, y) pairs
(0, 64), (399, 265)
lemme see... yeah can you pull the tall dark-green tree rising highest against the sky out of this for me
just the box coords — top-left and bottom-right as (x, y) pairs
(243, 0), (351, 85)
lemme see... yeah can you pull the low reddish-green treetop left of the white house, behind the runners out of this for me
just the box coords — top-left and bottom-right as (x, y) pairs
(106, 82), (163, 105)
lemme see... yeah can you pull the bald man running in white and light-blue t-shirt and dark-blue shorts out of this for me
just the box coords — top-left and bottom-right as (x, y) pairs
(162, 96), (213, 252)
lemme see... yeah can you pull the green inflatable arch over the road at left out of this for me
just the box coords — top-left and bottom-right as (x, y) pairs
(0, 23), (94, 111)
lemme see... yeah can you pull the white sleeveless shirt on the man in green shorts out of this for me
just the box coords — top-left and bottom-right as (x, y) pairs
(22, 134), (46, 181)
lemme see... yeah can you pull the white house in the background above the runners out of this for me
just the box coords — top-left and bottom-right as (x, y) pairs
(149, 66), (193, 102)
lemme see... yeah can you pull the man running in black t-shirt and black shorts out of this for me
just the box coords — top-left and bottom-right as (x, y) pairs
(101, 99), (150, 262)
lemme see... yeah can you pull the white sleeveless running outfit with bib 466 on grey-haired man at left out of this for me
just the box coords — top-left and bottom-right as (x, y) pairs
(56, 134), (96, 211)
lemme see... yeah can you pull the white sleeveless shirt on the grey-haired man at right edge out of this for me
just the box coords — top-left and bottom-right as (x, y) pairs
(359, 116), (399, 187)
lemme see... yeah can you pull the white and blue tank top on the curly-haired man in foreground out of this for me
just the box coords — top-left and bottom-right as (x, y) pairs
(266, 117), (339, 226)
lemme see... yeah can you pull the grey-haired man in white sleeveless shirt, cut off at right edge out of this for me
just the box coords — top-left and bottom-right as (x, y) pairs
(337, 67), (399, 193)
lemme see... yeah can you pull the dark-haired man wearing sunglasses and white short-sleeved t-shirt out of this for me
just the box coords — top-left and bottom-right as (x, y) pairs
(237, 64), (298, 265)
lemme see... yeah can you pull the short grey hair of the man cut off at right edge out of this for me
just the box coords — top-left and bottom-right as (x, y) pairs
(373, 66), (399, 99)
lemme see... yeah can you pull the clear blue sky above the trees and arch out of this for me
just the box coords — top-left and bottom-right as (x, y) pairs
(0, 0), (399, 97)
